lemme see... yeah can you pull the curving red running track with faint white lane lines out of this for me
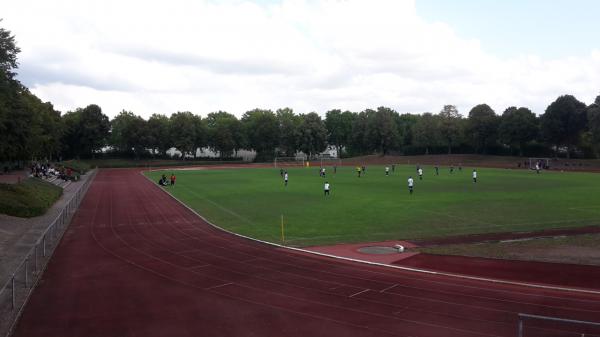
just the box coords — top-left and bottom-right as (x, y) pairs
(15, 170), (600, 337)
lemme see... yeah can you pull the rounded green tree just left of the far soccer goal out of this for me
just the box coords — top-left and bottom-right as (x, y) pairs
(242, 109), (279, 160)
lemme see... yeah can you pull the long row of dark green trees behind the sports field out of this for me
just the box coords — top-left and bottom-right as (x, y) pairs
(0, 22), (600, 162)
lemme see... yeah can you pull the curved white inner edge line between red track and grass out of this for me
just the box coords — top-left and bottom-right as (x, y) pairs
(139, 170), (600, 295)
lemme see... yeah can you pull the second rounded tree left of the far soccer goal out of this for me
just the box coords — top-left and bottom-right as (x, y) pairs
(205, 111), (242, 158)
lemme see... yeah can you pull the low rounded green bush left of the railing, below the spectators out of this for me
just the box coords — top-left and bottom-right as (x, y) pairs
(0, 178), (62, 218)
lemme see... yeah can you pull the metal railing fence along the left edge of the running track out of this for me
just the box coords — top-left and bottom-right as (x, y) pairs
(0, 170), (97, 336)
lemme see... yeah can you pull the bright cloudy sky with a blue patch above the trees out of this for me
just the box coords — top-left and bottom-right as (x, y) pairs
(0, 0), (600, 118)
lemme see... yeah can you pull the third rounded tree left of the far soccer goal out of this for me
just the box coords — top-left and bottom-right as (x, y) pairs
(170, 111), (198, 159)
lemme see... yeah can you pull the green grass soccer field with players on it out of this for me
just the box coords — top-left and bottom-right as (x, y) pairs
(146, 166), (600, 246)
